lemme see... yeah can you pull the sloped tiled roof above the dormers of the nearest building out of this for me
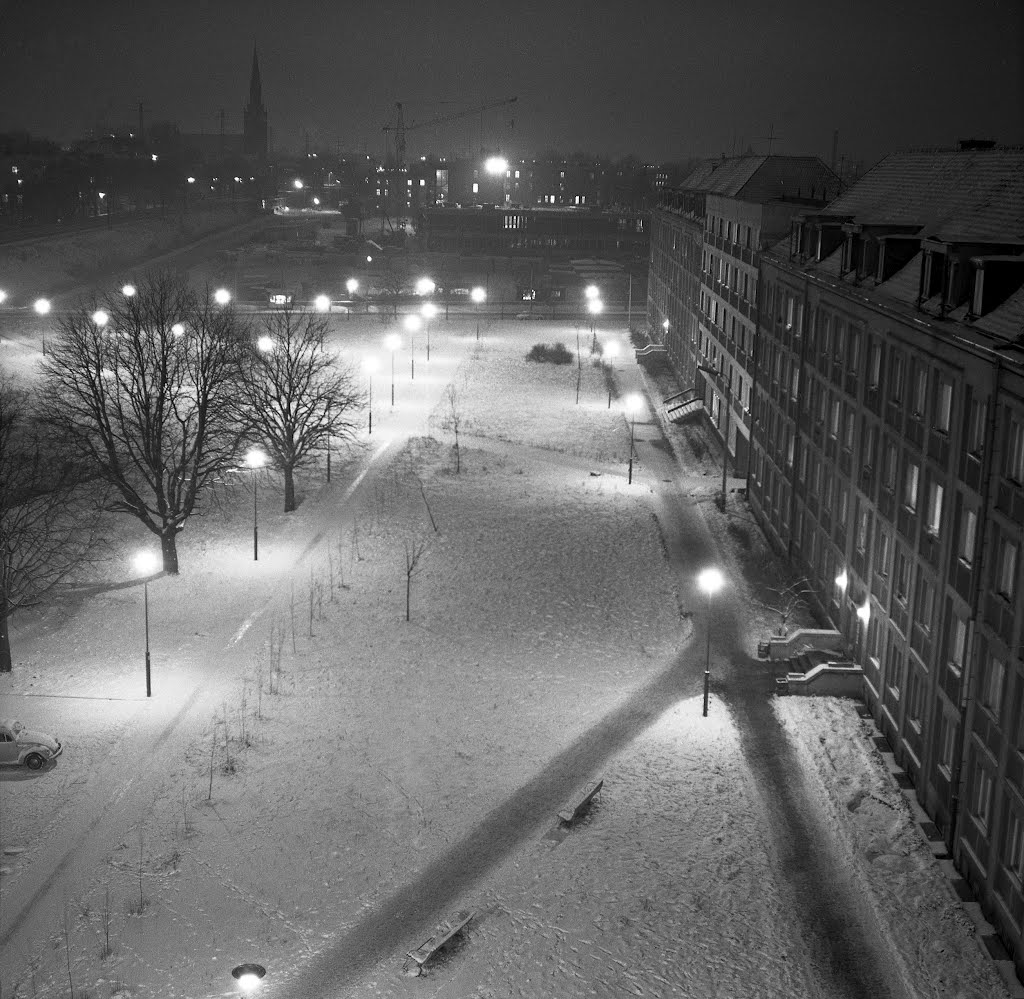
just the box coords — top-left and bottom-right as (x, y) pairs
(819, 148), (1024, 243)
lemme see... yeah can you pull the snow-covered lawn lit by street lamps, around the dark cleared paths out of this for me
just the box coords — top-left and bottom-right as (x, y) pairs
(0, 302), (1006, 999)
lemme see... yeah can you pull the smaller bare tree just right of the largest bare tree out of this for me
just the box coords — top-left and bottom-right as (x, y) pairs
(242, 311), (364, 513)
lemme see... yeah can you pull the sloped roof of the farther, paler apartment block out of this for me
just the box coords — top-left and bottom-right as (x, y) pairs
(680, 156), (839, 203)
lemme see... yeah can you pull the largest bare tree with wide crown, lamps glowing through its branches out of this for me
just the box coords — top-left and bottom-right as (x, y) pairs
(42, 273), (248, 573)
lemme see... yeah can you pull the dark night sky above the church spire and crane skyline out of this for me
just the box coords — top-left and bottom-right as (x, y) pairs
(0, 0), (1024, 164)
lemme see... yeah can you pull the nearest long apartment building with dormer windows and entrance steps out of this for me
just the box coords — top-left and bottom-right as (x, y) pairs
(745, 148), (1024, 971)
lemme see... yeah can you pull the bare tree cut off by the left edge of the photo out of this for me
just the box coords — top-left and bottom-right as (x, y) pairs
(0, 373), (102, 672)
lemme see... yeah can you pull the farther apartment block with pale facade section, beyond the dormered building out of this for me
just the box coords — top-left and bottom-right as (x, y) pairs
(648, 156), (839, 474)
